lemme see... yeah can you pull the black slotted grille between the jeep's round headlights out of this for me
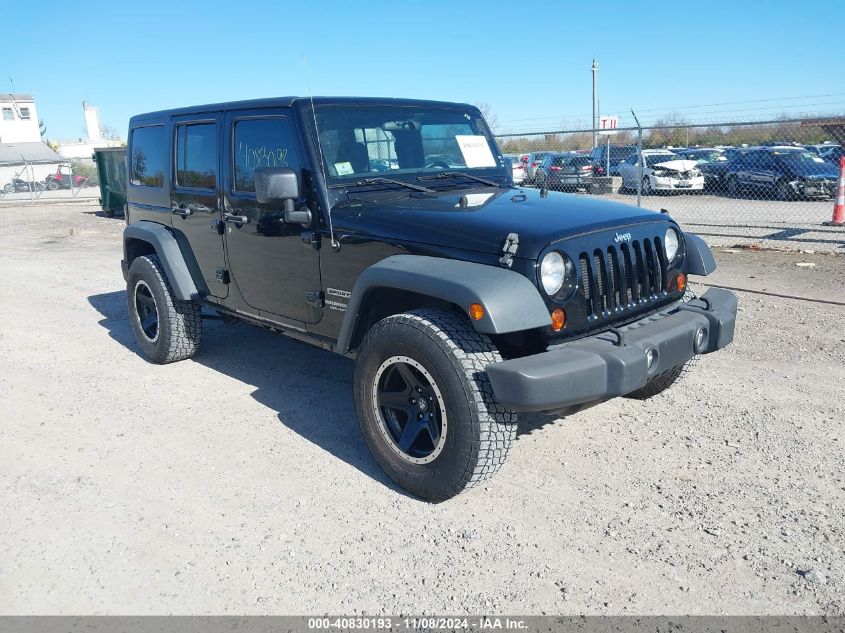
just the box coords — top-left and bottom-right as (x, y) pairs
(578, 237), (666, 317)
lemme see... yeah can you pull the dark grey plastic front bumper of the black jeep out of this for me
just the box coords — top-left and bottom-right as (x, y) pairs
(487, 288), (737, 411)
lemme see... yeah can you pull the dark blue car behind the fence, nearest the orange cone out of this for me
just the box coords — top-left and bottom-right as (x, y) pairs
(726, 146), (839, 200)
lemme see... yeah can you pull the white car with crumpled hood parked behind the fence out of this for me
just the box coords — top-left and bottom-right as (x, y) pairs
(619, 149), (704, 195)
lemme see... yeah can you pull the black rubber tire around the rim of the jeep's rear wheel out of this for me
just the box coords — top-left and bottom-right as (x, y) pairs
(126, 255), (202, 364)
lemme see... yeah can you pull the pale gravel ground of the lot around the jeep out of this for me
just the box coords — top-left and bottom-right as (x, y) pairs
(0, 203), (845, 614)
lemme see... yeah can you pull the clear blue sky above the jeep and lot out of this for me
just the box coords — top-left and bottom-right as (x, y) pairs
(0, 0), (845, 139)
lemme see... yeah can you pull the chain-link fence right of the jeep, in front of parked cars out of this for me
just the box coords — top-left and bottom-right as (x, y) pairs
(497, 119), (845, 252)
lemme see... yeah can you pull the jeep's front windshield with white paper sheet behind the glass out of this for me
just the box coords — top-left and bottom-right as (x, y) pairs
(316, 104), (510, 187)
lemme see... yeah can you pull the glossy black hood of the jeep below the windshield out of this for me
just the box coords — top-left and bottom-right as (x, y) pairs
(332, 188), (666, 259)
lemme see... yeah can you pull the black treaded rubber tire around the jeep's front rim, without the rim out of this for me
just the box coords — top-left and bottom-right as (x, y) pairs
(354, 309), (517, 502)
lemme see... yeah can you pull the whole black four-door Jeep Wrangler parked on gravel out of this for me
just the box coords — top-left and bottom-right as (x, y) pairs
(123, 98), (737, 500)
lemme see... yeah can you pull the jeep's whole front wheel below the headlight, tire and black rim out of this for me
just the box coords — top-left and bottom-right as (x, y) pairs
(354, 309), (516, 502)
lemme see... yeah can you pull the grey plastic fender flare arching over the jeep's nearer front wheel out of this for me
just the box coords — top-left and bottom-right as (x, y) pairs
(337, 255), (551, 354)
